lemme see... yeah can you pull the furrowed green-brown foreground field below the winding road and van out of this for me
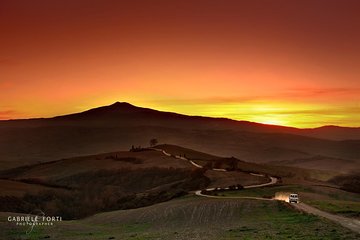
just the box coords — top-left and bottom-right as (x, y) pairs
(0, 196), (360, 240)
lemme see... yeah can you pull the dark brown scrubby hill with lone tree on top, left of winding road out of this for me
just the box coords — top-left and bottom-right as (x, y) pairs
(0, 146), (289, 219)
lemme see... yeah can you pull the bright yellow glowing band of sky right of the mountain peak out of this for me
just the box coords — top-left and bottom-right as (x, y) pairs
(145, 102), (360, 128)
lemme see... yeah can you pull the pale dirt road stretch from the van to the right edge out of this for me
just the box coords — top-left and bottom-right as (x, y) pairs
(291, 203), (360, 233)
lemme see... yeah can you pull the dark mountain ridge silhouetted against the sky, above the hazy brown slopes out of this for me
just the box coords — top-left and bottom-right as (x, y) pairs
(0, 102), (360, 140)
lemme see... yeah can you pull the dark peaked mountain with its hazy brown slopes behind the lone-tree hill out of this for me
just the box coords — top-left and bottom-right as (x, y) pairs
(0, 102), (360, 172)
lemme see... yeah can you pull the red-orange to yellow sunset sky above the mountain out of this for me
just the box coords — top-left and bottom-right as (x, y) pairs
(0, 0), (360, 127)
